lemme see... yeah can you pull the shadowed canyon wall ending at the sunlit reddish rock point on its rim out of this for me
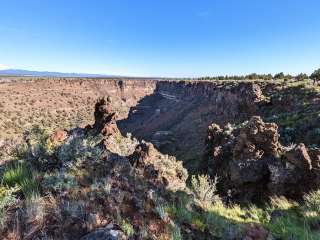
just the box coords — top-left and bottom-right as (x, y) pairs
(118, 81), (264, 170)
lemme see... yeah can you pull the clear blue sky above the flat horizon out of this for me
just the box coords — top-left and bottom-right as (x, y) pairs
(0, 0), (320, 77)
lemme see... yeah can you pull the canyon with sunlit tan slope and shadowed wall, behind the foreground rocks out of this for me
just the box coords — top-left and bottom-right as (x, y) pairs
(0, 77), (320, 172)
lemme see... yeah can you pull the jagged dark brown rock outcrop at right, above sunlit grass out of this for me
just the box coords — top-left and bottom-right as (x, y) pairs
(207, 116), (320, 202)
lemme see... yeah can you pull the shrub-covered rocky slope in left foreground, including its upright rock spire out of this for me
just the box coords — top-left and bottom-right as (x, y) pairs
(1, 99), (188, 239)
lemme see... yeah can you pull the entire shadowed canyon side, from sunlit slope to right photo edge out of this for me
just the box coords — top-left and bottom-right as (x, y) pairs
(118, 81), (320, 173)
